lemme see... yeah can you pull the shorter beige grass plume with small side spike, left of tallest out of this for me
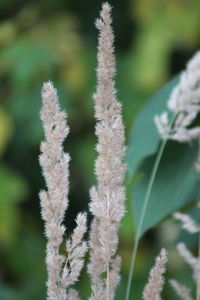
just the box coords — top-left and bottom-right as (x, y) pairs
(40, 82), (87, 300)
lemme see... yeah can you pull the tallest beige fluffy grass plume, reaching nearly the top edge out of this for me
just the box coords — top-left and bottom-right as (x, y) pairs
(88, 3), (126, 300)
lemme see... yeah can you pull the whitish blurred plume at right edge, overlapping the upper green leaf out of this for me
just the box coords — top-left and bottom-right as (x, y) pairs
(155, 51), (200, 142)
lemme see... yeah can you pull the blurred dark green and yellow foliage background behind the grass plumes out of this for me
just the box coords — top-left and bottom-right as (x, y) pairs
(0, 0), (200, 300)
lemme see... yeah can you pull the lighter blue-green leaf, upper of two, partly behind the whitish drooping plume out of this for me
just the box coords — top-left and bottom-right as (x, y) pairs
(127, 76), (179, 178)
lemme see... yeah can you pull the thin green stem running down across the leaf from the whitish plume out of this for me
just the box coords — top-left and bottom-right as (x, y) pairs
(125, 114), (177, 300)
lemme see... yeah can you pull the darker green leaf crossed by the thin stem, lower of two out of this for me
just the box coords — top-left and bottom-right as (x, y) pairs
(132, 142), (199, 235)
